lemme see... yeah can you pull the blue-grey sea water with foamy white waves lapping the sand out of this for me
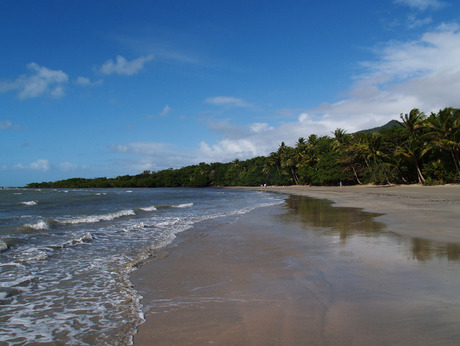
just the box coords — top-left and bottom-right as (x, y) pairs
(0, 188), (284, 345)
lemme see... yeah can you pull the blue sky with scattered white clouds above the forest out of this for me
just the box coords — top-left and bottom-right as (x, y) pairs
(0, 0), (460, 186)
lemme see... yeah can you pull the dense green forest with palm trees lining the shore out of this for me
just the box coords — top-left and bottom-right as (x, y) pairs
(27, 108), (460, 188)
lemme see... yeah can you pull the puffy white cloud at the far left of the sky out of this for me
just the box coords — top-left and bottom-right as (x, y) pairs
(0, 62), (69, 99)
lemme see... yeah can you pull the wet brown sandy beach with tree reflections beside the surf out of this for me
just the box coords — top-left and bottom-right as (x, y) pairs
(131, 185), (460, 345)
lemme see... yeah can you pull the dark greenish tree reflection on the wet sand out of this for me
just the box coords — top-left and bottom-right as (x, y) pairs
(280, 195), (460, 262)
